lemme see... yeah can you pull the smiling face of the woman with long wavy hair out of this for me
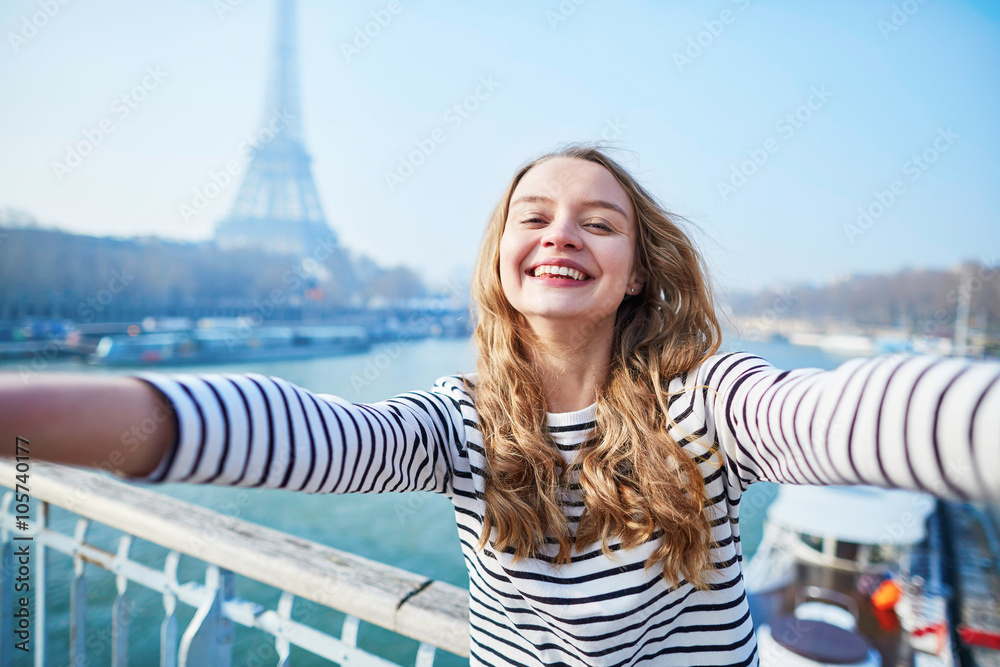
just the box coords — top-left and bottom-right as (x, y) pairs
(500, 157), (642, 331)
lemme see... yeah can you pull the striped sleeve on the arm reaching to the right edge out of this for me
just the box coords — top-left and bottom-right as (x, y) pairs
(698, 353), (1000, 500)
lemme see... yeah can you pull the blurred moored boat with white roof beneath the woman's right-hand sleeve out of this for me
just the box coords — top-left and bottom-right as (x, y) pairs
(745, 486), (1000, 667)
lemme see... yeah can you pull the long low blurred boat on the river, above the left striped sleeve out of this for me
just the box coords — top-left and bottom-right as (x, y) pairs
(87, 326), (371, 366)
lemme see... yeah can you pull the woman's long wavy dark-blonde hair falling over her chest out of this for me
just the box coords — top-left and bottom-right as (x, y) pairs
(472, 145), (721, 588)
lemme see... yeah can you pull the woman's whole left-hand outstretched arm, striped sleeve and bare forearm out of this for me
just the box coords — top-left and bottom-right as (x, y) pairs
(0, 373), (467, 494)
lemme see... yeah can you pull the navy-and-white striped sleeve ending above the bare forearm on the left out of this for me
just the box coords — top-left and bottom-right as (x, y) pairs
(120, 373), (464, 495)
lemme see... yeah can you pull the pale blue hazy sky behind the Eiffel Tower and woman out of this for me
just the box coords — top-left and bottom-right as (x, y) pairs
(0, 0), (1000, 288)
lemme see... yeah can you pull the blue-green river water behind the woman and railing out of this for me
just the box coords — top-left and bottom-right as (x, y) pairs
(0, 339), (844, 667)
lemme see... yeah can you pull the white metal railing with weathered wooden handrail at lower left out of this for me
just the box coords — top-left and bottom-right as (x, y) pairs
(0, 459), (469, 667)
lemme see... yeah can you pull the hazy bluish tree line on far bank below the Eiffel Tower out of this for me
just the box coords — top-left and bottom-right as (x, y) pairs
(0, 224), (436, 321)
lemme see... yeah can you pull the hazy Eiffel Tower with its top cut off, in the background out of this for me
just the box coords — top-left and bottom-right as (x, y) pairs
(215, 0), (336, 257)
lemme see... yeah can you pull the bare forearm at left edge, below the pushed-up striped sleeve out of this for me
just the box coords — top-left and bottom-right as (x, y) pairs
(0, 373), (177, 477)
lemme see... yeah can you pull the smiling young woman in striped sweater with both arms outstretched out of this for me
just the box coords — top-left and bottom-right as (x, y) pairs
(0, 147), (1000, 665)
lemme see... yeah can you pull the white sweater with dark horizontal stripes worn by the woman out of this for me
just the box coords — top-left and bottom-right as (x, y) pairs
(127, 353), (1000, 666)
